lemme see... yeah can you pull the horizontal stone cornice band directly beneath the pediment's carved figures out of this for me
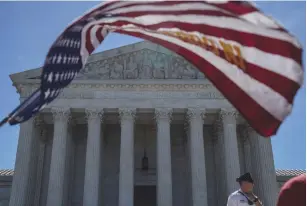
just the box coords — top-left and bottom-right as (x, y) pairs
(15, 82), (225, 100)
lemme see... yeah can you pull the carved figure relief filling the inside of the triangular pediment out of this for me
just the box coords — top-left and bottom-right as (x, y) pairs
(77, 49), (204, 79)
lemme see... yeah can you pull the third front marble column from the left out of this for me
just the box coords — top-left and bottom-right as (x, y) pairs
(83, 109), (103, 206)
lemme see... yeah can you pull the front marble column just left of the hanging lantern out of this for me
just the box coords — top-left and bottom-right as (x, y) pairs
(118, 108), (136, 206)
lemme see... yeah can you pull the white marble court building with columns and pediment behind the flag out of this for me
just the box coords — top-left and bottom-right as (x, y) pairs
(3, 41), (306, 206)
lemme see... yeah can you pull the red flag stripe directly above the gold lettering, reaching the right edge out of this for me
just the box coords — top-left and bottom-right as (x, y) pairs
(100, 19), (302, 65)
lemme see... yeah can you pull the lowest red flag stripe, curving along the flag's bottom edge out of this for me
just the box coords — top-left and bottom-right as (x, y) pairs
(116, 30), (281, 137)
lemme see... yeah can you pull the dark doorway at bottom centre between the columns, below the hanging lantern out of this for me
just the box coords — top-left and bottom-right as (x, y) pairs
(134, 185), (156, 206)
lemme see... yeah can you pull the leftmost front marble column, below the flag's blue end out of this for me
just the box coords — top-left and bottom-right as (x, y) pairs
(9, 117), (39, 206)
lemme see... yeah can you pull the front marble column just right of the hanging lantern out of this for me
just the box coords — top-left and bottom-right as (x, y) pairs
(155, 108), (173, 206)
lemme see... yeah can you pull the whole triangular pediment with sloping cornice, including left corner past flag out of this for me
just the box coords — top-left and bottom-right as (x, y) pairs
(10, 41), (204, 82)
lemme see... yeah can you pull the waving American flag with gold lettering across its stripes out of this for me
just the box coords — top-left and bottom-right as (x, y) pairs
(2, 1), (303, 137)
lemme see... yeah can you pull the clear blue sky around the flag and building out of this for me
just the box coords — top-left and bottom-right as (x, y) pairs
(0, 2), (306, 169)
